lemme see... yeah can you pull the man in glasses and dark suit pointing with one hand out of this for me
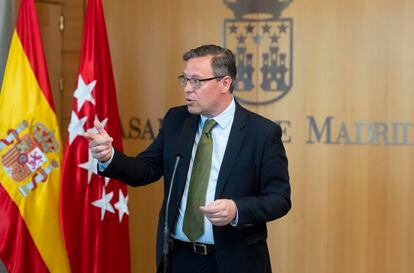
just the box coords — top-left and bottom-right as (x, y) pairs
(87, 45), (291, 273)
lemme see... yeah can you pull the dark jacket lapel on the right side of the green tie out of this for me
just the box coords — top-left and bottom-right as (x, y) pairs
(215, 102), (247, 199)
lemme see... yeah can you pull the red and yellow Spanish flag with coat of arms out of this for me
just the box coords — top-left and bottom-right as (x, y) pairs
(0, 0), (70, 273)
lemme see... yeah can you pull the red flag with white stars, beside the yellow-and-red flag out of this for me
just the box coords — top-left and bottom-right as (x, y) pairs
(61, 0), (131, 273)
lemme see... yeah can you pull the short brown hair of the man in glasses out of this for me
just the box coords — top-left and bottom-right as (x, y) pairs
(183, 45), (237, 92)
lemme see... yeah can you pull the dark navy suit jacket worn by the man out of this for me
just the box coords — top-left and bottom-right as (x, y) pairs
(99, 103), (291, 273)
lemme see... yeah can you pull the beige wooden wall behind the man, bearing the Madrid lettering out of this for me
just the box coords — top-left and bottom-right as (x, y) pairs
(91, 0), (414, 273)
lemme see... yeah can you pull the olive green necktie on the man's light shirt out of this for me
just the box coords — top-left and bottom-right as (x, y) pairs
(183, 119), (217, 242)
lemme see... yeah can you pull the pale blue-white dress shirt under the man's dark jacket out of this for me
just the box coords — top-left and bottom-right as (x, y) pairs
(172, 98), (236, 244)
